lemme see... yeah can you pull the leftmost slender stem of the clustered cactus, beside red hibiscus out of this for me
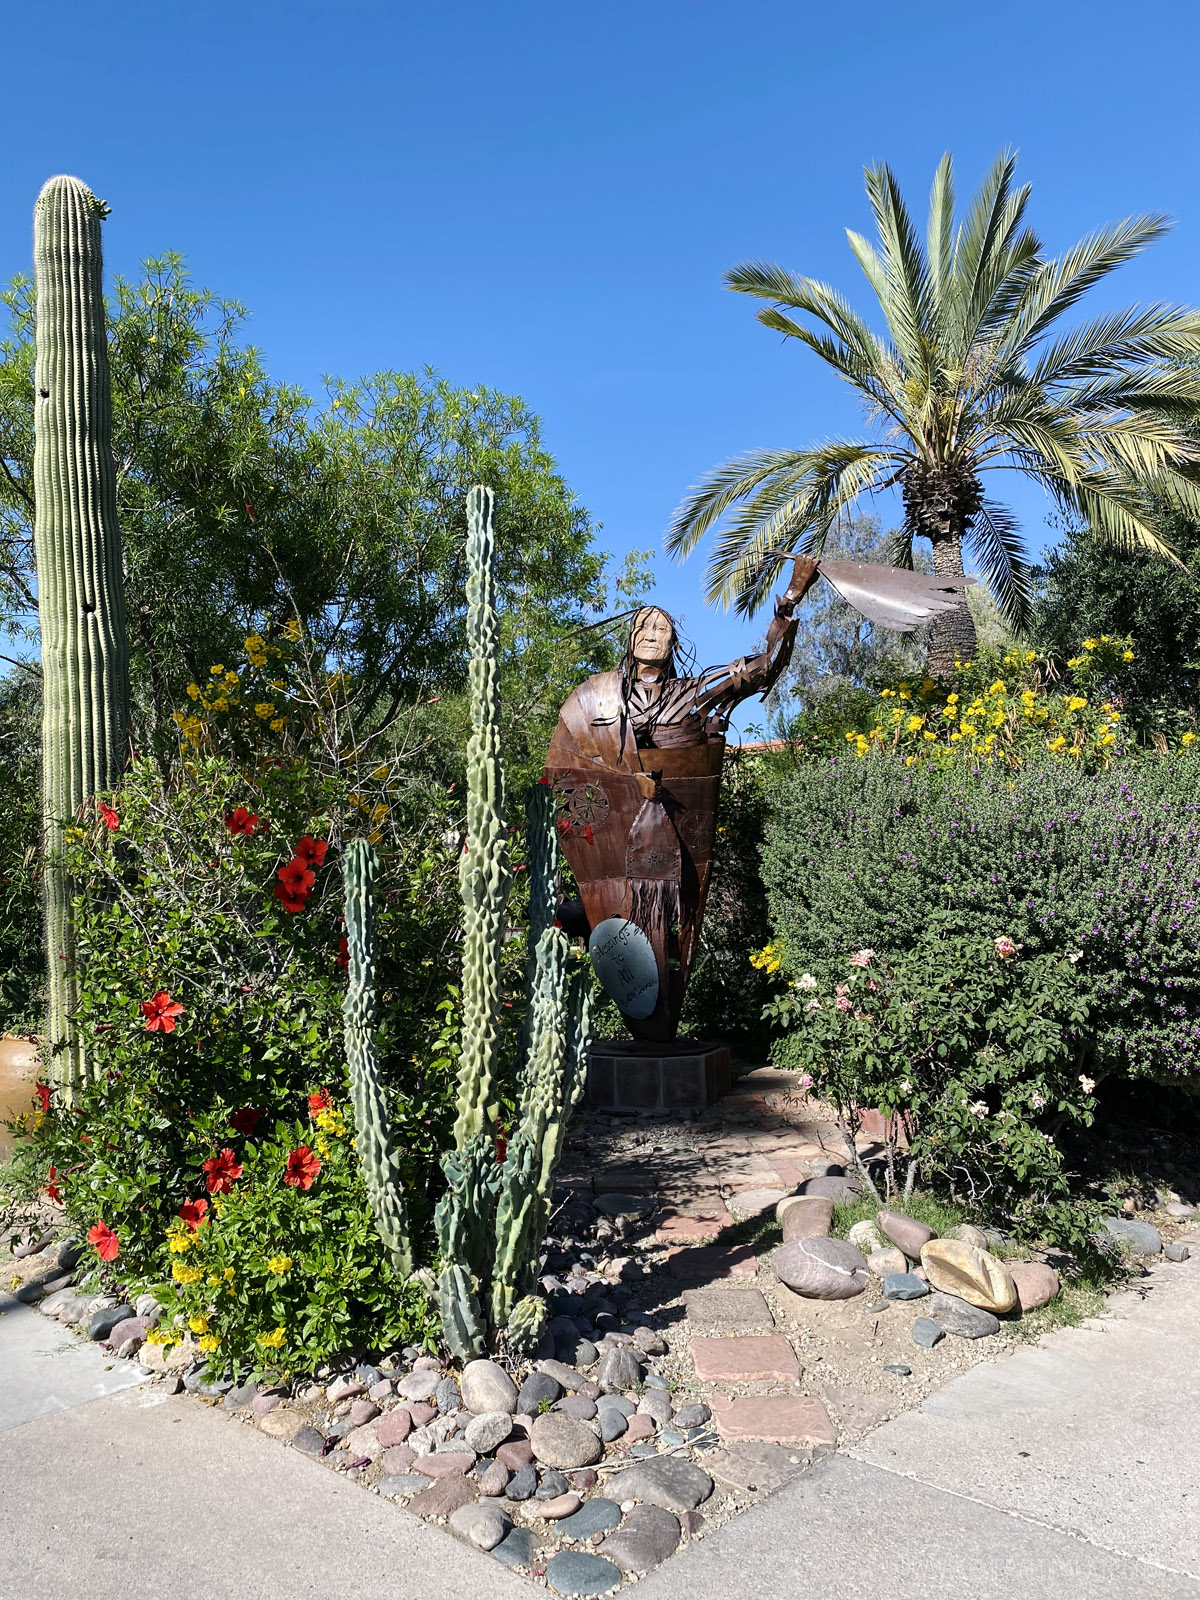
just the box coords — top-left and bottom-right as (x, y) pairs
(342, 838), (413, 1278)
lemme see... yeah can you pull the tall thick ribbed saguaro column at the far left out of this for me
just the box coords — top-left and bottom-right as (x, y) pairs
(34, 178), (130, 1085)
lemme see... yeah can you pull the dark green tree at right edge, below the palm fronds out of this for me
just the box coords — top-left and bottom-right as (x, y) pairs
(1030, 518), (1200, 728)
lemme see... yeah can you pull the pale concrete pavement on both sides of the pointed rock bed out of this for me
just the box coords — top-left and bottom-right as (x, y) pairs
(0, 1261), (1200, 1600)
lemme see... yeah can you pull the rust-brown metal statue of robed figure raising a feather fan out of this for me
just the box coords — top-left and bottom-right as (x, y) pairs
(546, 552), (973, 1042)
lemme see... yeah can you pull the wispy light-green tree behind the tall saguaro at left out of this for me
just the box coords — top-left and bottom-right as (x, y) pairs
(0, 254), (640, 744)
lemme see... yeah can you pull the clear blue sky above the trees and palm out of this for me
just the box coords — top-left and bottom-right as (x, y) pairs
(0, 0), (1200, 732)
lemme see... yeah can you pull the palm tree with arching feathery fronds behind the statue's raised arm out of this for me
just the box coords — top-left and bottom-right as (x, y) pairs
(667, 154), (1200, 677)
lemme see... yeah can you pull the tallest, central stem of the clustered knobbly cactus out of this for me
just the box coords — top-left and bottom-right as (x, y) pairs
(454, 488), (512, 1150)
